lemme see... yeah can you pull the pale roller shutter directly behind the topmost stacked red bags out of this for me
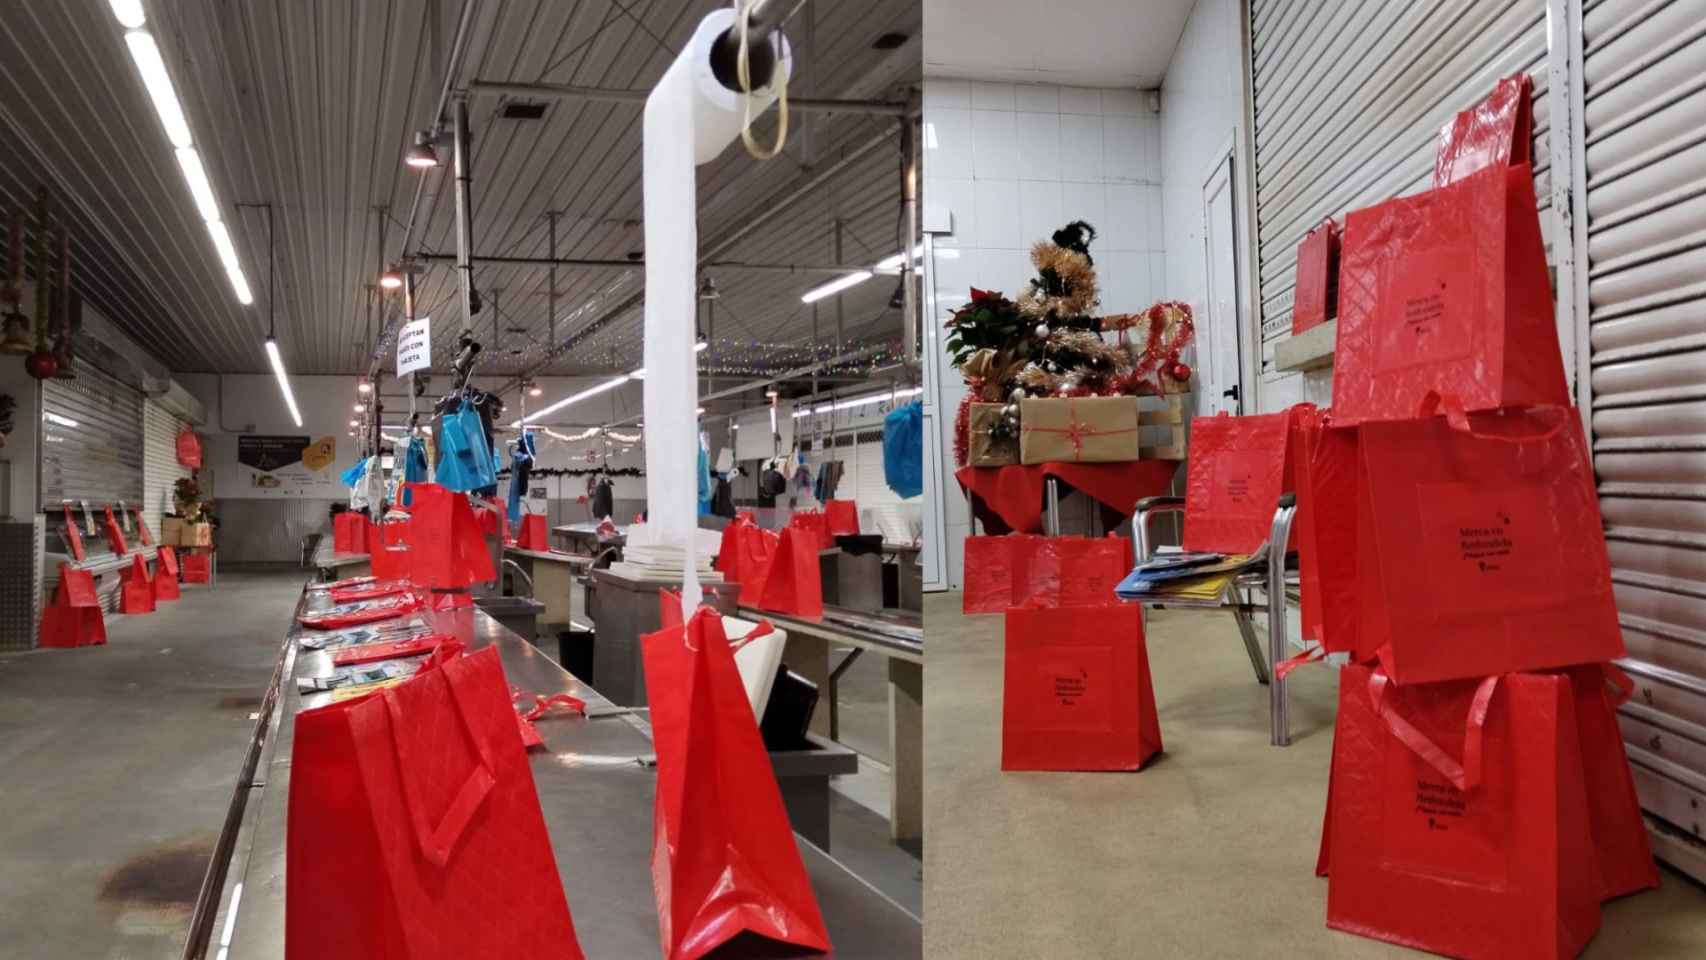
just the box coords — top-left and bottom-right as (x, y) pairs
(1250, 0), (1555, 411)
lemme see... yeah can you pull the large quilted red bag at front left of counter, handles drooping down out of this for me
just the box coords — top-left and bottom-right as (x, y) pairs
(285, 646), (582, 960)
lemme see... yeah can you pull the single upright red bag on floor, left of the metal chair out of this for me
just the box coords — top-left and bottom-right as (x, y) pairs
(1001, 604), (1162, 771)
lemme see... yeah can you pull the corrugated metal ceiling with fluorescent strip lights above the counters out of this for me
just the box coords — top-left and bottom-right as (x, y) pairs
(0, 0), (921, 381)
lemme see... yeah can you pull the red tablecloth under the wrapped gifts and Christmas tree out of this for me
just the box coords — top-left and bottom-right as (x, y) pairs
(954, 460), (1179, 534)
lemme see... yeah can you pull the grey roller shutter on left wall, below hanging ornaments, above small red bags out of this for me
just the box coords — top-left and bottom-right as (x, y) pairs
(41, 363), (142, 510)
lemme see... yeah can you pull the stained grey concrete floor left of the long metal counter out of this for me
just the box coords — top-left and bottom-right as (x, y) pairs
(0, 571), (304, 960)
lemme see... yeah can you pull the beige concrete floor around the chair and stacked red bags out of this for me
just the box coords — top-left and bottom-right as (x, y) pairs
(925, 593), (1706, 960)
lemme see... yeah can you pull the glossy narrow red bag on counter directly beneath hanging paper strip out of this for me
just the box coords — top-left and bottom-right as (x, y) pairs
(640, 613), (829, 960)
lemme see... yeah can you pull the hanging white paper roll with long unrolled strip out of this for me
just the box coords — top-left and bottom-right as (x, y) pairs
(643, 7), (792, 614)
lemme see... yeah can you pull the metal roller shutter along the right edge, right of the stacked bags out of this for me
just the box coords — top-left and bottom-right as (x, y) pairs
(1580, 0), (1706, 880)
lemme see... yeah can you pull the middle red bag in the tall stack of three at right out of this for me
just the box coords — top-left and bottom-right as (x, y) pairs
(1351, 408), (1624, 684)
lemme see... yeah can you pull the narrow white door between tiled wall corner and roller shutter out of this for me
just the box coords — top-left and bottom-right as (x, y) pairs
(1198, 152), (1244, 416)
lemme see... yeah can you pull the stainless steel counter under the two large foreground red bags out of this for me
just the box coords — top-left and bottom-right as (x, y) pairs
(208, 595), (923, 960)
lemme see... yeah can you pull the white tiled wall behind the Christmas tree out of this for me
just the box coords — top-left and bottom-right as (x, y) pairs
(923, 78), (1167, 587)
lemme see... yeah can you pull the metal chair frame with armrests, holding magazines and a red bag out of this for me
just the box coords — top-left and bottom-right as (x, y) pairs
(1131, 493), (1298, 747)
